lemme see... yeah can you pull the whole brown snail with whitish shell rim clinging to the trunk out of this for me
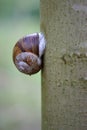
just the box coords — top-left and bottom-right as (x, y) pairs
(13, 33), (46, 75)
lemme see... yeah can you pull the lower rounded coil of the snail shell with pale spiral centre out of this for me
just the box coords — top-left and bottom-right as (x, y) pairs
(15, 52), (41, 75)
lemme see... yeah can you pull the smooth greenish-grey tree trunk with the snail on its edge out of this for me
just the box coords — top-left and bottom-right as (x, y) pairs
(41, 0), (87, 130)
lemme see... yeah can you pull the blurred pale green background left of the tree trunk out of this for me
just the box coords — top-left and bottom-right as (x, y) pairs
(0, 0), (41, 130)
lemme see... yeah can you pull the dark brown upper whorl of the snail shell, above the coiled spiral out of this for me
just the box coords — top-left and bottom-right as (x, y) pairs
(13, 33), (39, 63)
